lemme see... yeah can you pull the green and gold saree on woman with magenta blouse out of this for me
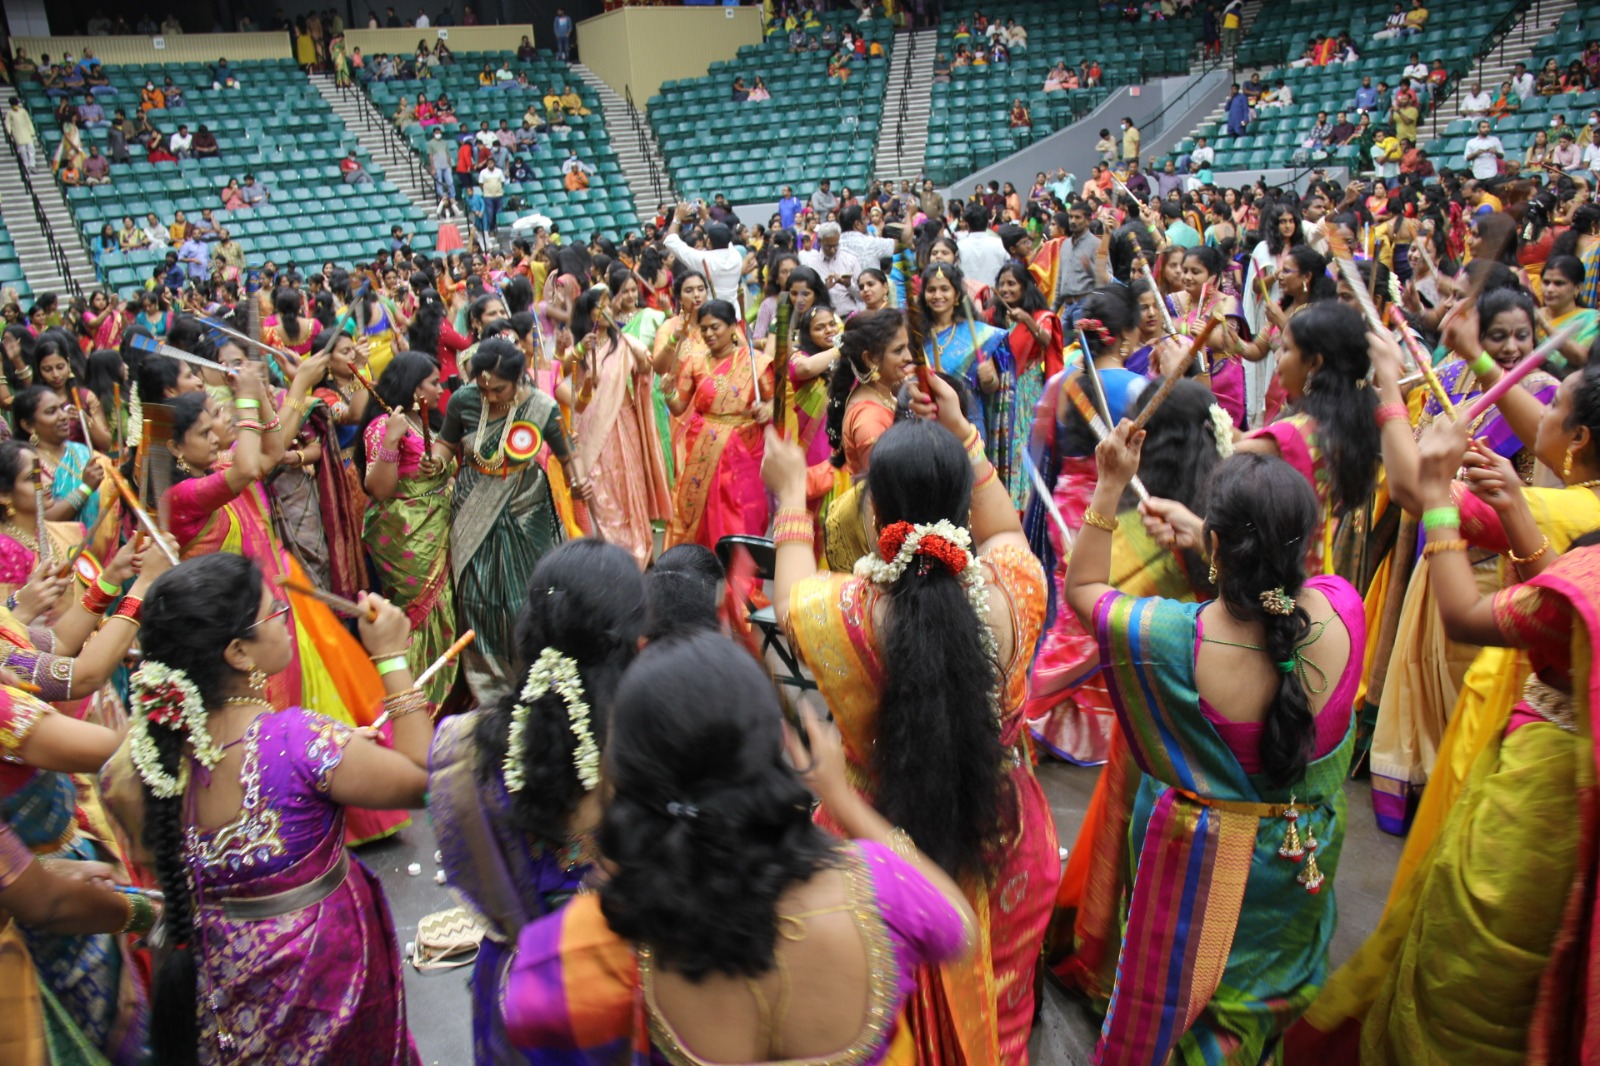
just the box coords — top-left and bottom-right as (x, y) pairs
(362, 415), (456, 704)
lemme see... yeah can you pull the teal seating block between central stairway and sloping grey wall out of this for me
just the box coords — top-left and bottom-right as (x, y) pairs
(923, 0), (1200, 182)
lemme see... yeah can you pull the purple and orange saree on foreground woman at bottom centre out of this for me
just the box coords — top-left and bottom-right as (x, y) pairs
(501, 840), (966, 1066)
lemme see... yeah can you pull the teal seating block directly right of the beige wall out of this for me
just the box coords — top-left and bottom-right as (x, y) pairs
(650, 8), (894, 203)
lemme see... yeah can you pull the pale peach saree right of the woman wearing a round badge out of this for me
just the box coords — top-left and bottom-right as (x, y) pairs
(574, 334), (672, 570)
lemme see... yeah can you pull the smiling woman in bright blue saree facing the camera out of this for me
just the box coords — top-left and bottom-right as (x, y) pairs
(918, 262), (1027, 480)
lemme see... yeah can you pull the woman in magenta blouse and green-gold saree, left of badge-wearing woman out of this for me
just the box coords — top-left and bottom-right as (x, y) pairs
(362, 352), (456, 703)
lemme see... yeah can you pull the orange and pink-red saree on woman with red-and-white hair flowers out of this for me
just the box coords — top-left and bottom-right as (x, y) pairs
(789, 547), (1061, 1066)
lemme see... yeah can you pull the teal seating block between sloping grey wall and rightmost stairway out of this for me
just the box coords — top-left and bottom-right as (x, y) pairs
(1173, 0), (1520, 171)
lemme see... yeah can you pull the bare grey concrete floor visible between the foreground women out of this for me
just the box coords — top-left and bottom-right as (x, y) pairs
(358, 762), (1402, 1066)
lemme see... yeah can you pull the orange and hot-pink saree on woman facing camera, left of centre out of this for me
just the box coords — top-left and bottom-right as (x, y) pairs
(666, 349), (773, 549)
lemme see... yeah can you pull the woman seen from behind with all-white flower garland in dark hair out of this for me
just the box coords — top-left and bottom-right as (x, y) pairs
(427, 538), (645, 1066)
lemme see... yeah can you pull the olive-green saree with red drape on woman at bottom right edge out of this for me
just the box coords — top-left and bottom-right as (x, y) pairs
(1290, 549), (1600, 1066)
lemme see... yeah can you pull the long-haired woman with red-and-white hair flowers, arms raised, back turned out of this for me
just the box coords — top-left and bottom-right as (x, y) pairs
(763, 377), (1061, 1063)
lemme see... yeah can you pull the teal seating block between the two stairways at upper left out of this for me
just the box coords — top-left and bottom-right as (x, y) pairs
(366, 51), (638, 240)
